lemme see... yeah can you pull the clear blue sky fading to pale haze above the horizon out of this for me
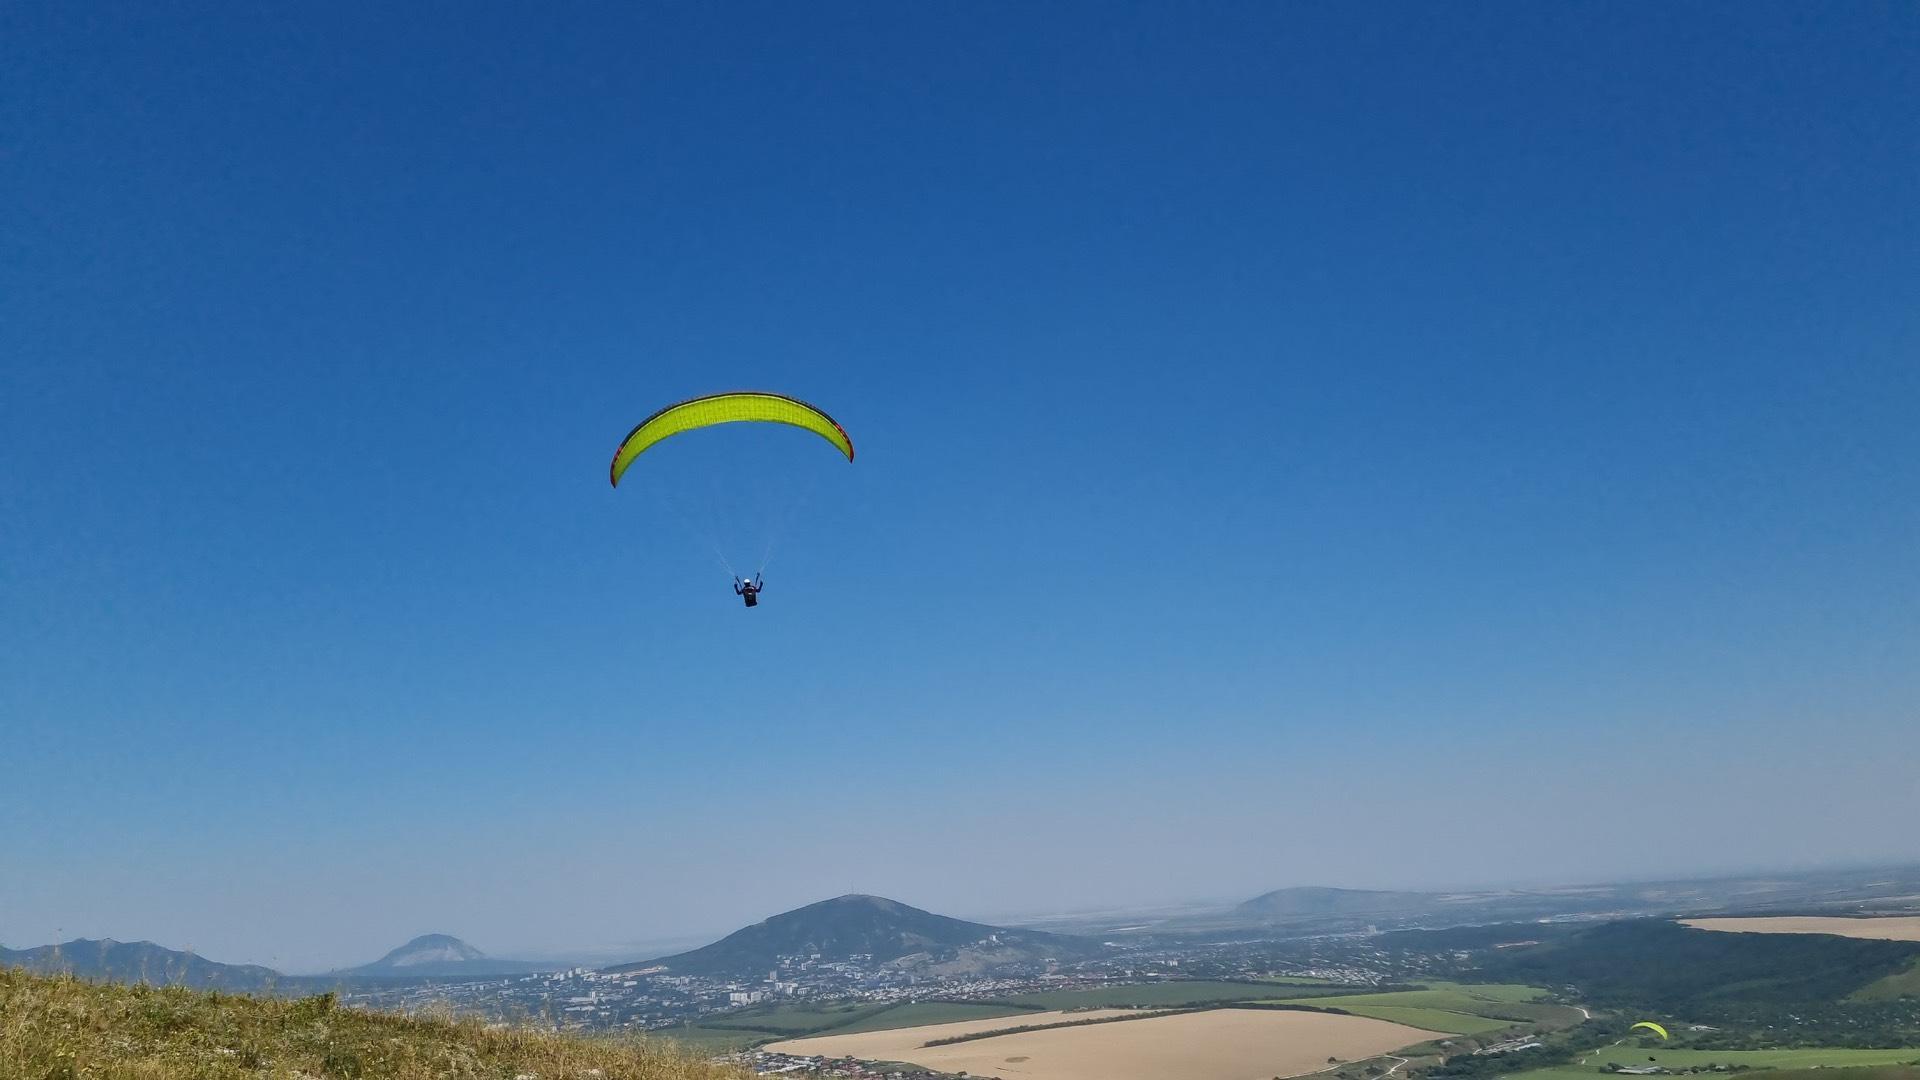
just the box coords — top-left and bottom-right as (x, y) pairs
(0, 4), (1920, 970)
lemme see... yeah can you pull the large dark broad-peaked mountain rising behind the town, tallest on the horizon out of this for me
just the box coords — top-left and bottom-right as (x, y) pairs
(607, 896), (1100, 978)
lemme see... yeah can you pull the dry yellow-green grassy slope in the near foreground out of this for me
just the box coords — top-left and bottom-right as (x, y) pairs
(0, 969), (741, 1080)
